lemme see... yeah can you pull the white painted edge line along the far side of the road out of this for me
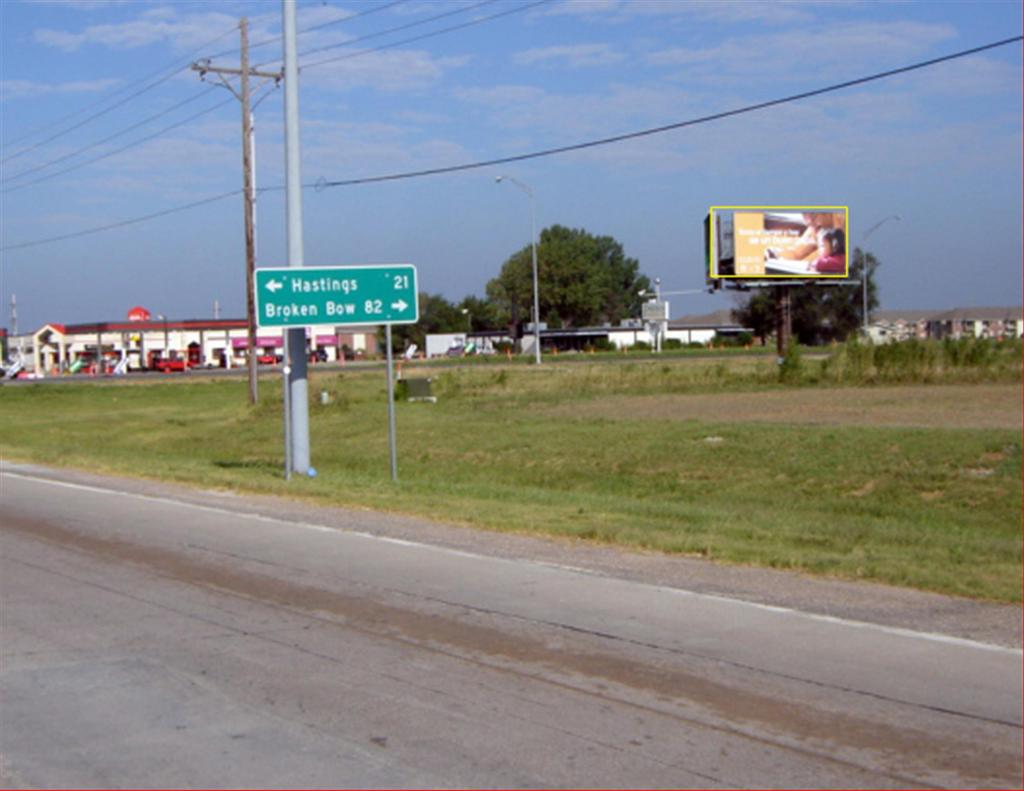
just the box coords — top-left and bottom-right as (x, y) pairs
(0, 469), (1024, 657)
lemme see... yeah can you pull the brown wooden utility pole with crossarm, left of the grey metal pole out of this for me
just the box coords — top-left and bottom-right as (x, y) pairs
(191, 17), (283, 404)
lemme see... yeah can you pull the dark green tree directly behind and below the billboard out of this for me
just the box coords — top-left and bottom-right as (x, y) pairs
(733, 248), (880, 345)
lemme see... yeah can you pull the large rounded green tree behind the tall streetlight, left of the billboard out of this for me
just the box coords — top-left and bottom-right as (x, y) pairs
(486, 225), (650, 328)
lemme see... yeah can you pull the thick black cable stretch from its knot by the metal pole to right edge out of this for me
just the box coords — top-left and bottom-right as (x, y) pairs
(313, 36), (1024, 190)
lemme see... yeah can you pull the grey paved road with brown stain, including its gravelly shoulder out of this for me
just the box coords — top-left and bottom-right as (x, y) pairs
(0, 464), (1022, 788)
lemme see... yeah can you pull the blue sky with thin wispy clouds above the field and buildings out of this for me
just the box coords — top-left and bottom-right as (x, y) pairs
(0, 0), (1022, 331)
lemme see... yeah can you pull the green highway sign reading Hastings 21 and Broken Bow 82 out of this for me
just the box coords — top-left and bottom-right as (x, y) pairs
(256, 263), (420, 327)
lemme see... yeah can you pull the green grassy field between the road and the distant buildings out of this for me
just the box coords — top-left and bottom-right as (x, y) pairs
(0, 336), (1022, 601)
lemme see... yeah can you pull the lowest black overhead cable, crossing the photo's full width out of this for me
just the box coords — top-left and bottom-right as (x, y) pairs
(0, 36), (1024, 252)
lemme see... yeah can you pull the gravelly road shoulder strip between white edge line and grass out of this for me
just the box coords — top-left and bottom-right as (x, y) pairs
(0, 462), (1022, 649)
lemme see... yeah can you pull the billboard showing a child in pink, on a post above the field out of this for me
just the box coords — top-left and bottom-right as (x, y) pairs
(705, 206), (850, 281)
